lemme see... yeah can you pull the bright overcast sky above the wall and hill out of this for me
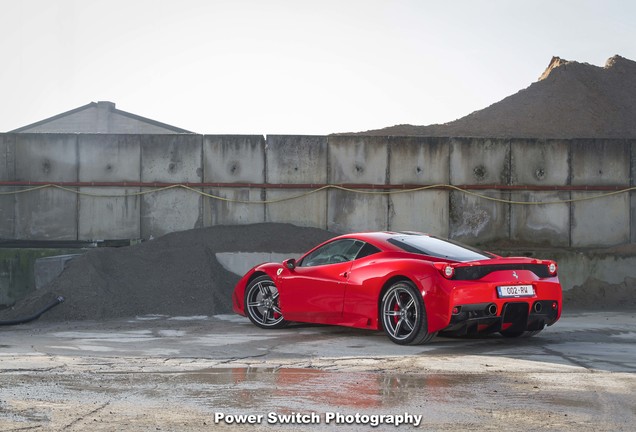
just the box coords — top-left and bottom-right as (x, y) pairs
(0, 0), (636, 135)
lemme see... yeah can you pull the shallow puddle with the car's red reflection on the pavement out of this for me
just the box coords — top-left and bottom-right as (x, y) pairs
(169, 368), (476, 410)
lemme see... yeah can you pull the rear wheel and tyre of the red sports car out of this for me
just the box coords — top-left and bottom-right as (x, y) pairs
(380, 281), (437, 345)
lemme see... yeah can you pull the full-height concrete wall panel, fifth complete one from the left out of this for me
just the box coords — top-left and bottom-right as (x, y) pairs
(265, 135), (328, 228)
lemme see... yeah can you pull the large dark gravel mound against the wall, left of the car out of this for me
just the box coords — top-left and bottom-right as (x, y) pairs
(0, 223), (335, 321)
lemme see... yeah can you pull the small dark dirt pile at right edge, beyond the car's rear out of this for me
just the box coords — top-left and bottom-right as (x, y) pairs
(563, 277), (636, 311)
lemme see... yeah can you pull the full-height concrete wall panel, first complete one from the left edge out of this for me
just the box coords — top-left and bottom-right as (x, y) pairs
(15, 134), (78, 240)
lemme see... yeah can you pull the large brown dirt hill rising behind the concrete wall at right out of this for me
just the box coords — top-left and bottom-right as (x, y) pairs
(360, 56), (636, 139)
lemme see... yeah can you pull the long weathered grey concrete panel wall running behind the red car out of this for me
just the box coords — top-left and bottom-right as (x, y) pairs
(0, 134), (636, 247)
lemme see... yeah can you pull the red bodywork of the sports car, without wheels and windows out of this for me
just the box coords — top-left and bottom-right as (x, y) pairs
(232, 232), (562, 333)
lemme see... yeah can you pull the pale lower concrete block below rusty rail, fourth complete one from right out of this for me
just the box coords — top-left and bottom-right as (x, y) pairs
(389, 190), (450, 237)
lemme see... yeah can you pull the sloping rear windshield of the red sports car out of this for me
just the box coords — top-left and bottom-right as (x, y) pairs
(388, 235), (492, 261)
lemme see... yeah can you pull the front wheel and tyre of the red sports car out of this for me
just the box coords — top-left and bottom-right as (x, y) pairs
(245, 276), (288, 329)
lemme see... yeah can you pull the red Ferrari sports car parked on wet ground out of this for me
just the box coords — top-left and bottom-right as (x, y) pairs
(232, 232), (561, 345)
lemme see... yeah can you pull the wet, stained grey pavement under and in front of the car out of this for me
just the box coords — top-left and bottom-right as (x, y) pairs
(0, 312), (636, 431)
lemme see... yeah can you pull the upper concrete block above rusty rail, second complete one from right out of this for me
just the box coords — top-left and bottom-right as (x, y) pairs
(510, 139), (570, 186)
